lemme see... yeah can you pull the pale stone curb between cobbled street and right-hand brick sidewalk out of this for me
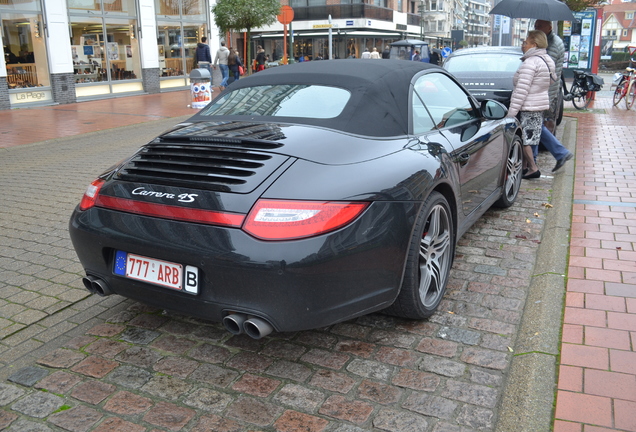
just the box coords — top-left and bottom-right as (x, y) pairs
(495, 117), (577, 432)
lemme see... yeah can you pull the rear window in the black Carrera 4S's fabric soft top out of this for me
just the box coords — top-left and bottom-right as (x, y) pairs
(200, 84), (351, 119)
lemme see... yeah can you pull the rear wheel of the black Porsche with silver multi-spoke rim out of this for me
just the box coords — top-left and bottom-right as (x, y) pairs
(386, 192), (455, 319)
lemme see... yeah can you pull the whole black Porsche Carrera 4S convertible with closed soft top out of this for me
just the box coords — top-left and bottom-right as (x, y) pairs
(70, 60), (522, 338)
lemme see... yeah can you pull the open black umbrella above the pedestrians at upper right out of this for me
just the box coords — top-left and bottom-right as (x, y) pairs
(490, 0), (574, 21)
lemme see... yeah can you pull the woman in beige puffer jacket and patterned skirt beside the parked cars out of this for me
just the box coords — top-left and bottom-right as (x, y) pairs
(508, 30), (556, 179)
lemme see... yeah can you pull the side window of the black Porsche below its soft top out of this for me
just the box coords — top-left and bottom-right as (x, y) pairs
(413, 73), (477, 134)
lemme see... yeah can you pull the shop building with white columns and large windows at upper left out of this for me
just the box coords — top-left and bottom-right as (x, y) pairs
(0, 0), (218, 109)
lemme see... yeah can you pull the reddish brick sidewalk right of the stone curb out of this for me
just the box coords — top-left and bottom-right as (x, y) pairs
(554, 92), (636, 432)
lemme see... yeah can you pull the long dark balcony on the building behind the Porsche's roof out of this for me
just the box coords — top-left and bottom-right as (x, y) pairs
(294, 3), (392, 25)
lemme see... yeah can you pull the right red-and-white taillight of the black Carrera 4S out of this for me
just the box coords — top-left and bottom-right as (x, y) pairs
(243, 200), (369, 240)
